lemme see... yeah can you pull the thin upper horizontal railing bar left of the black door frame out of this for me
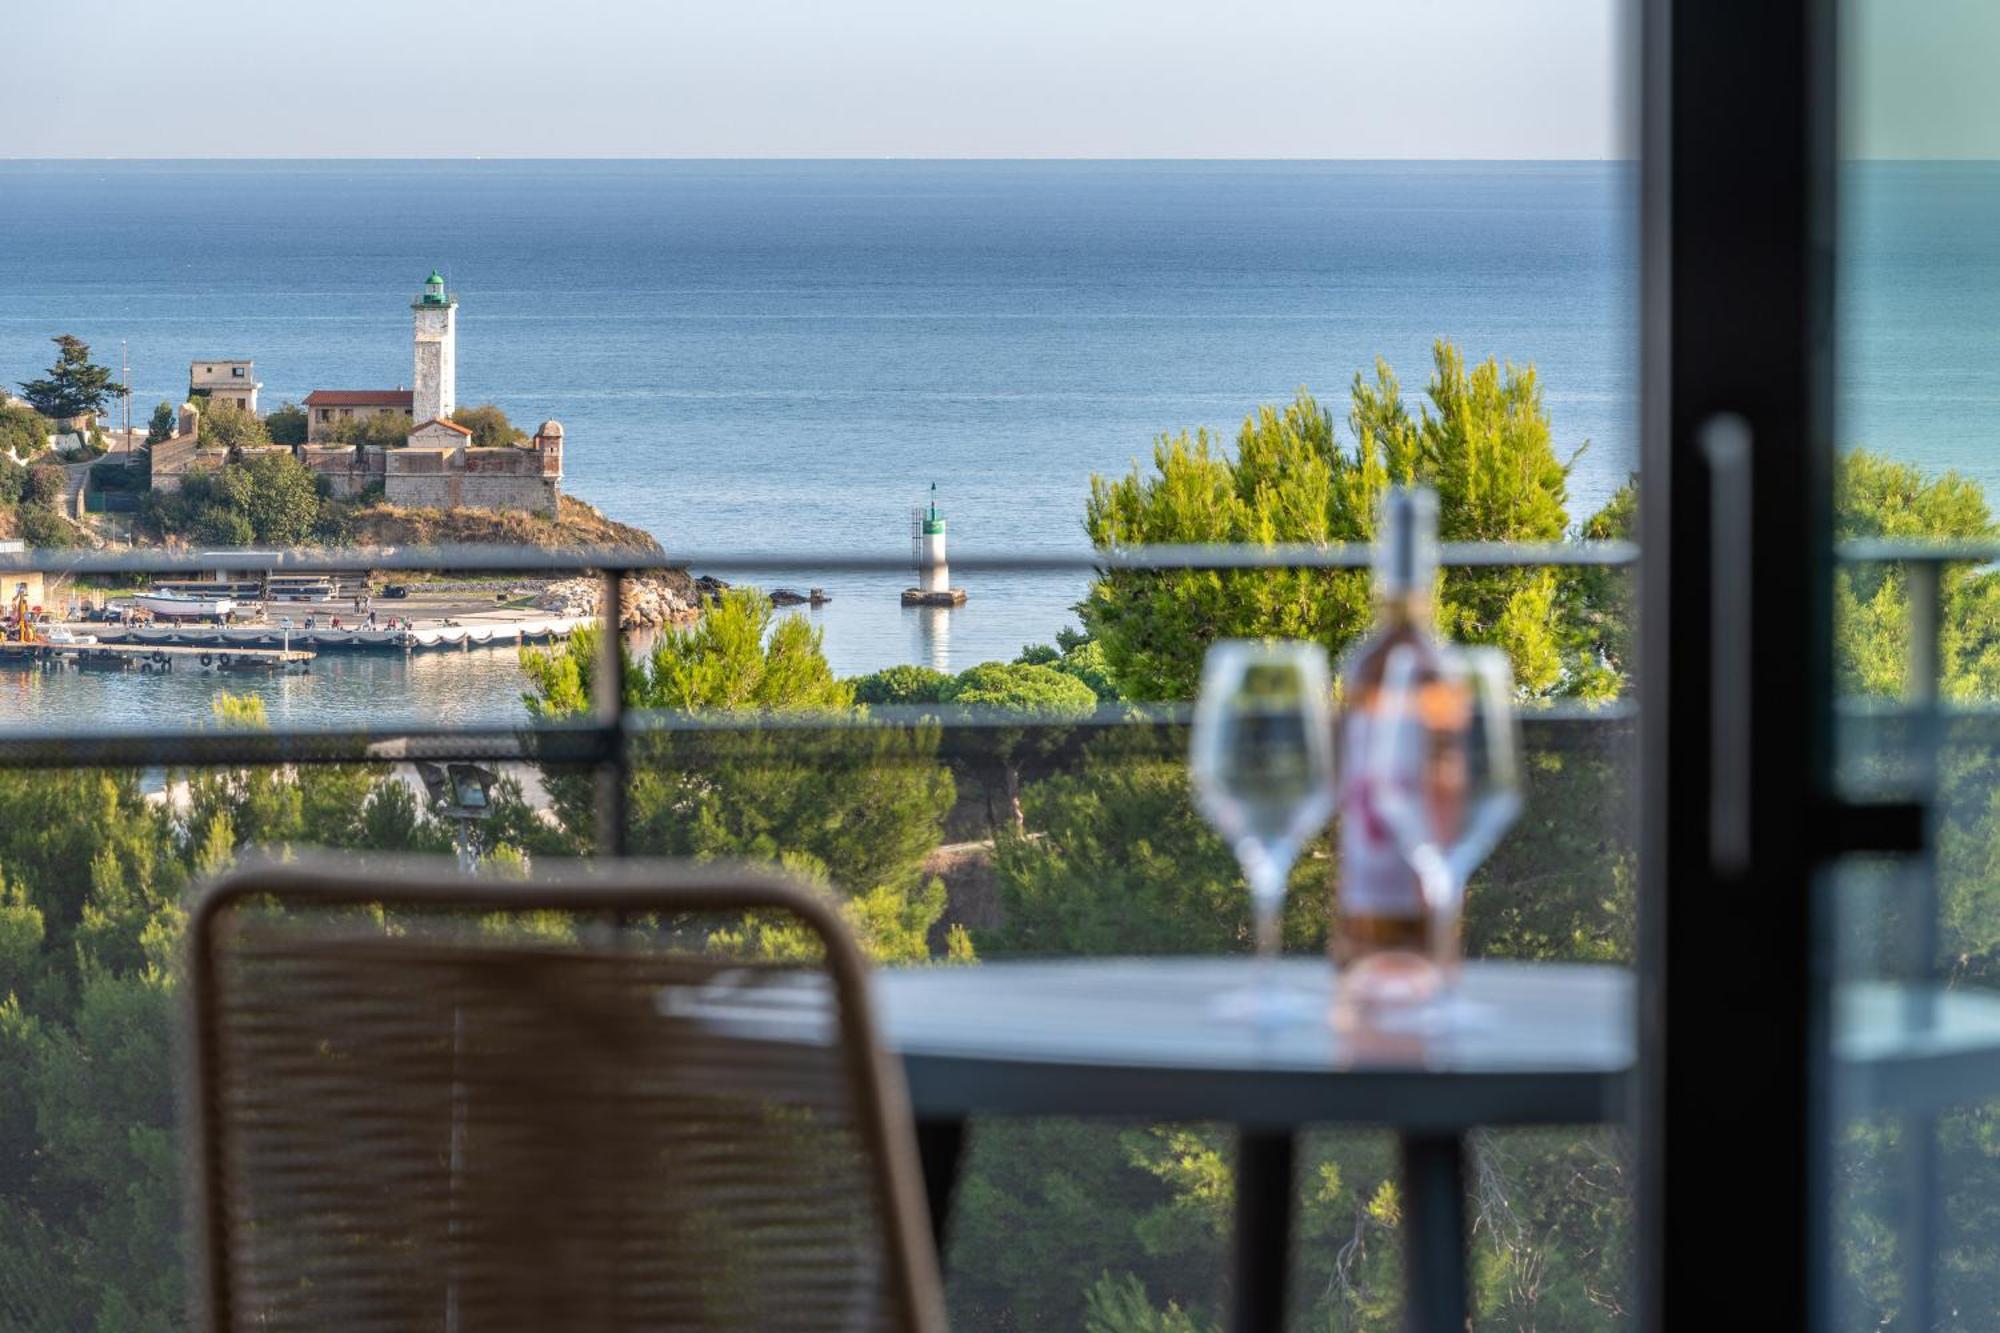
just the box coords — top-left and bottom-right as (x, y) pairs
(0, 542), (1638, 576)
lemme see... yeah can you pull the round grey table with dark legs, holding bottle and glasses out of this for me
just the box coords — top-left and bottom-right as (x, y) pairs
(876, 957), (1636, 1329)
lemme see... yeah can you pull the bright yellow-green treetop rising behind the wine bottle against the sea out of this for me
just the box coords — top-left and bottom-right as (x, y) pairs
(1078, 342), (1618, 699)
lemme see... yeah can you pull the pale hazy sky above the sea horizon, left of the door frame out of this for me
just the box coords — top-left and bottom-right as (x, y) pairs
(0, 0), (1632, 158)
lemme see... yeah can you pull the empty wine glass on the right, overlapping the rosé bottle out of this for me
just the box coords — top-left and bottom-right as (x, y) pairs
(1368, 646), (1520, 1012)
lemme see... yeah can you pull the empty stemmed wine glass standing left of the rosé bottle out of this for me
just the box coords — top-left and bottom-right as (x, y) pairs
(1188, 638), (1334, 1021)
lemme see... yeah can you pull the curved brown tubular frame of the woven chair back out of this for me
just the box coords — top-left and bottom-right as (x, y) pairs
(186, 855), (946, 1333)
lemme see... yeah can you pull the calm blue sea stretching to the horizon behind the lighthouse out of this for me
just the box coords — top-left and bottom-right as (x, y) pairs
(0, 160), (1976, 727)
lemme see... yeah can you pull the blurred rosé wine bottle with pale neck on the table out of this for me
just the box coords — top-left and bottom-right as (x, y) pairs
(1328, 486), (1470, 1009)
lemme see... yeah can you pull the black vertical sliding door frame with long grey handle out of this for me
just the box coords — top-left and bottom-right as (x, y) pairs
(1634, 0), (1840, 1333)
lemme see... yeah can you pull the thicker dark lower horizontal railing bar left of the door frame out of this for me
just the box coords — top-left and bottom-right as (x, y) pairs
(0, 705), (1634, 769)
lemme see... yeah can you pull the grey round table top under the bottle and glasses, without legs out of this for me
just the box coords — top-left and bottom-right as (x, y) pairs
(876, 957), (1634, 1131)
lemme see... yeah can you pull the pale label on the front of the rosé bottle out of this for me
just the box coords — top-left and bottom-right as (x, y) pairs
(1340, 709), (1424, 919)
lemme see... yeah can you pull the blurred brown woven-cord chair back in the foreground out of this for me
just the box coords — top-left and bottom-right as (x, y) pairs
(190, 861), (942, 1333)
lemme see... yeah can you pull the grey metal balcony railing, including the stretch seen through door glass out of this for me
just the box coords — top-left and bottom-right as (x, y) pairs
(15, 542), (2000, 1320)
